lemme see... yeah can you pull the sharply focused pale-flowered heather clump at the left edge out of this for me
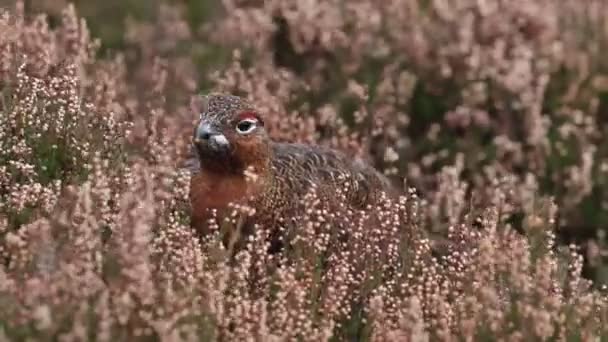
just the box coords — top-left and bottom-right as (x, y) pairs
(0, 2), (129, 227)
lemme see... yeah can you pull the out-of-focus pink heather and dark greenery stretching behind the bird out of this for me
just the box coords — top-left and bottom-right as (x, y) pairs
(0, 0), (608, 282)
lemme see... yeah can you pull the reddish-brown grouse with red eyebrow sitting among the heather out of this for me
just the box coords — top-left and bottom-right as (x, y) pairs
(190, 94), (391, 248)
